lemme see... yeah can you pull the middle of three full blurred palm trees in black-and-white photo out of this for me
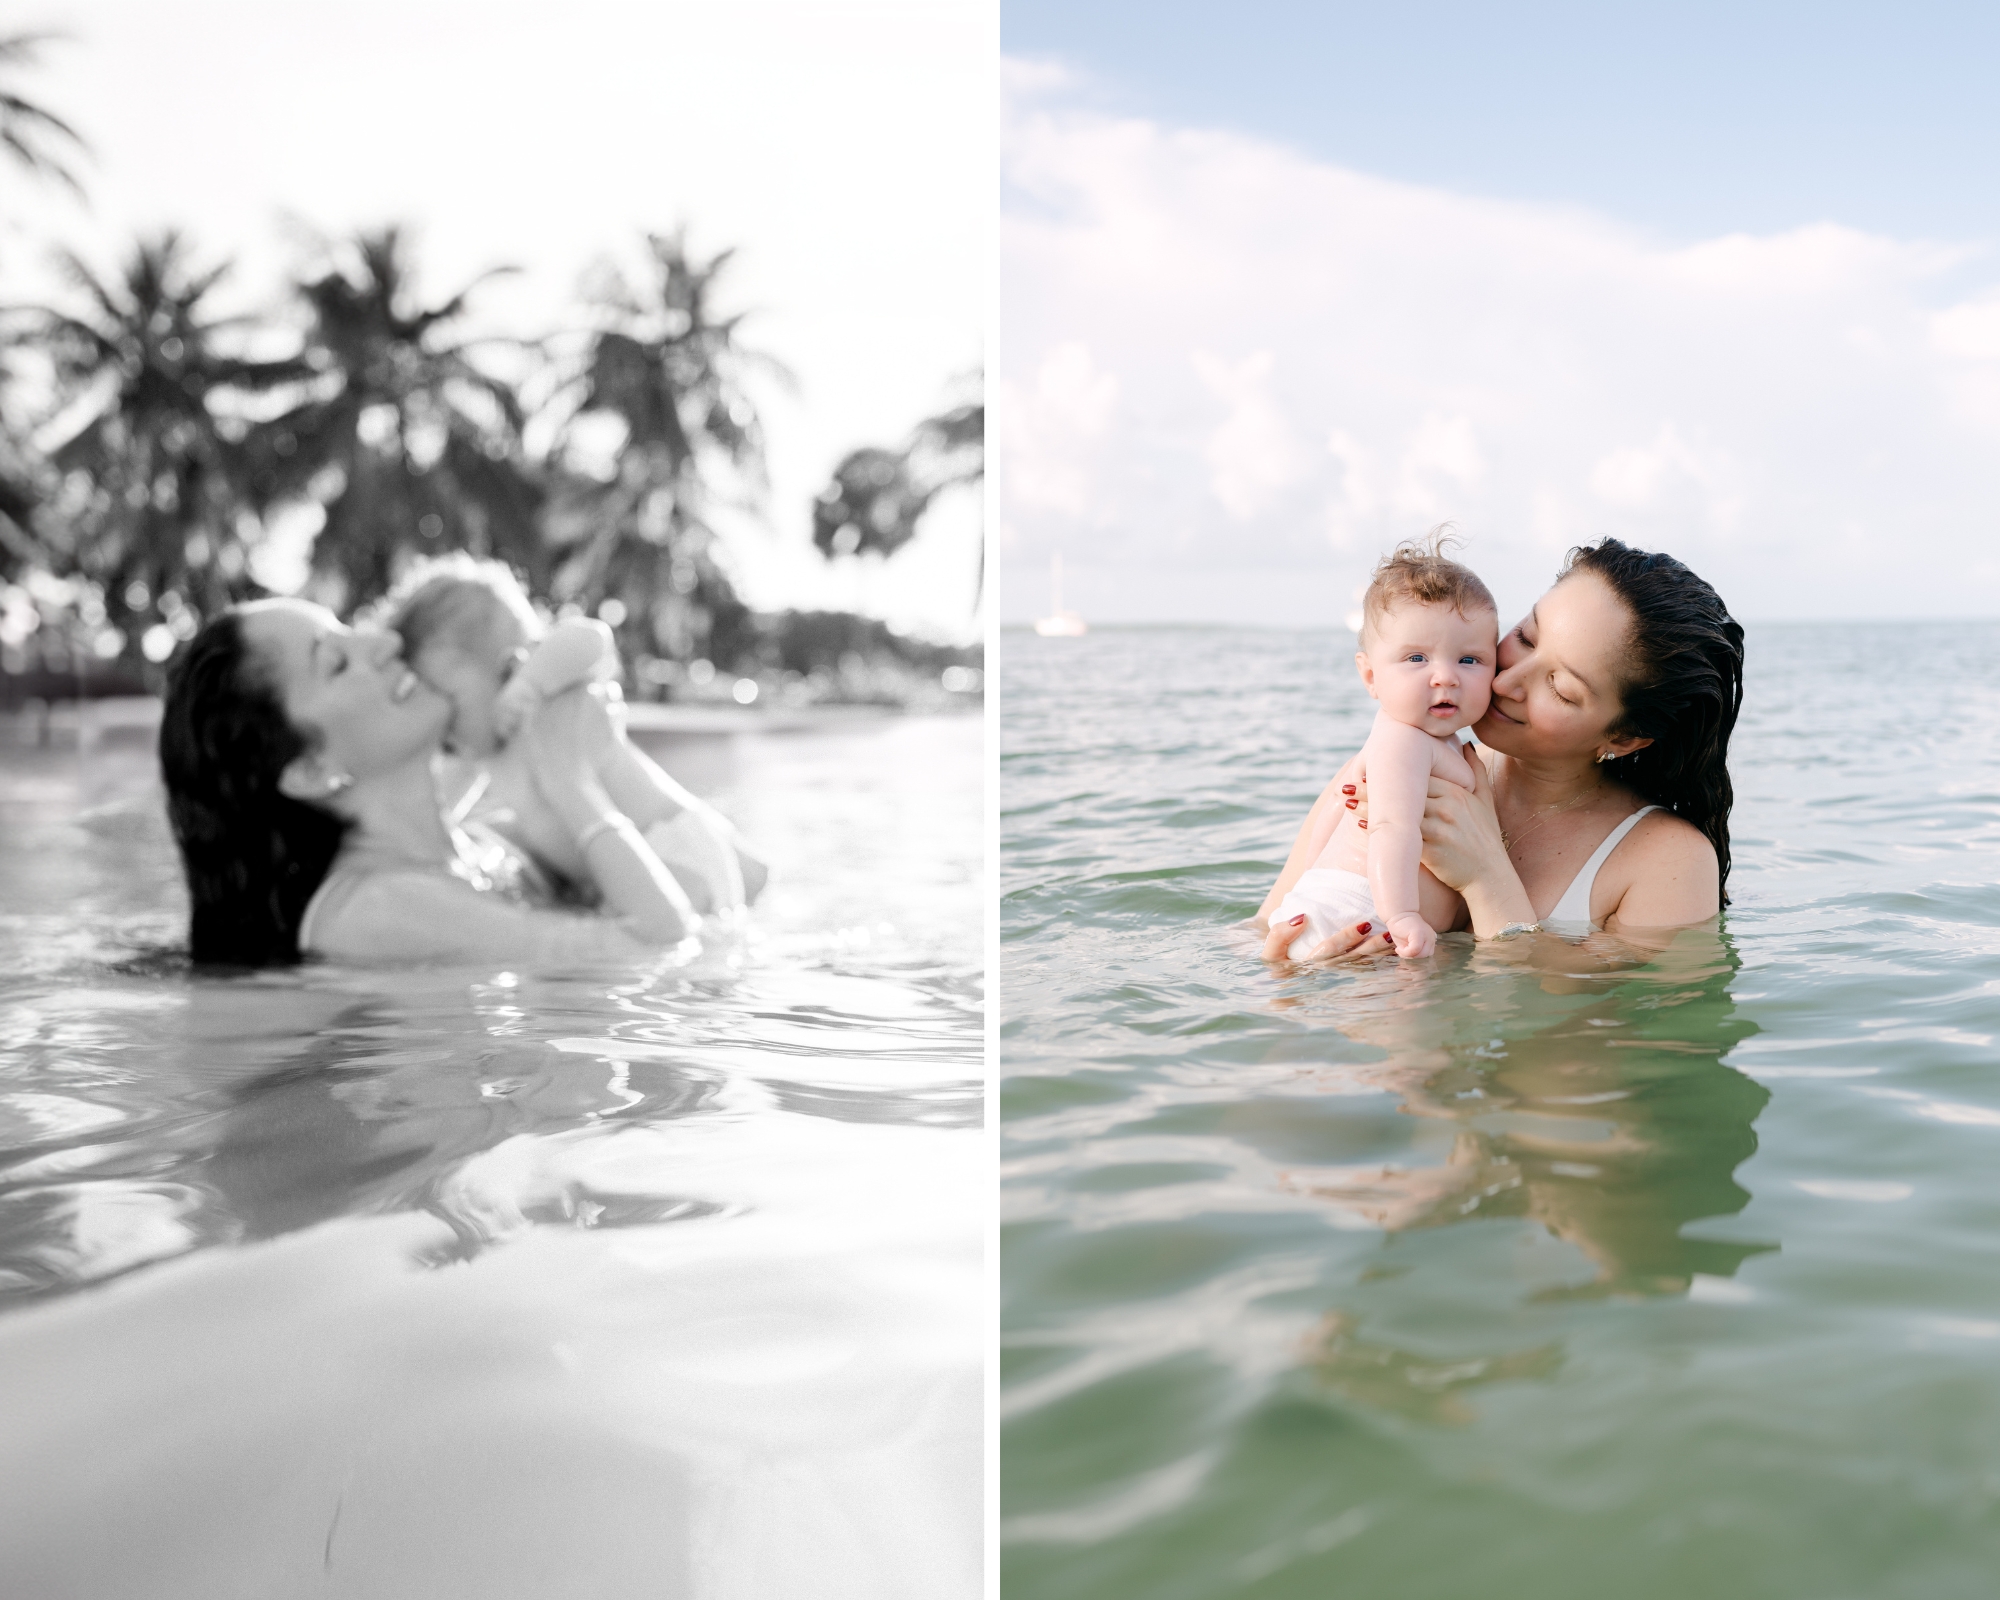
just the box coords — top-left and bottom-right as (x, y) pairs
(254, 226), (548, 606)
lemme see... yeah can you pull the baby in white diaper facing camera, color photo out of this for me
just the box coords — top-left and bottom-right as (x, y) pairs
(1272, 542), (1500, 956)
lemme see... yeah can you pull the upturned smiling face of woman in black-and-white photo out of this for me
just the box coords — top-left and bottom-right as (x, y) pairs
(242, 600), (452, 778)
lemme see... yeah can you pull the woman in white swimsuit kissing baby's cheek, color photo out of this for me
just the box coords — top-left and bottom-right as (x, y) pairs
(1258, 538), (1744, 960)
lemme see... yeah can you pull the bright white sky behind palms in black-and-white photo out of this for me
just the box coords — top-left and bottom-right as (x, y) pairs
(0, 0), (996, 638)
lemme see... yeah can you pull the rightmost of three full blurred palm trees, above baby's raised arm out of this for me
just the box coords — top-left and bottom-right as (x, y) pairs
(548, 228), (790, 662)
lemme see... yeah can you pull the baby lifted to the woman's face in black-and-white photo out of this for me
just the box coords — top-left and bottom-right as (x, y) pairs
(382, 556), (766, 914)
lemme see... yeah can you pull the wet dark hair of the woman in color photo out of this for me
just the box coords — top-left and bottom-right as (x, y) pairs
(1562, 538), (1744, 906)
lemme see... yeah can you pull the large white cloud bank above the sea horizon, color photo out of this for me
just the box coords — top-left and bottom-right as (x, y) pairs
(1000, 72), (2000, 622)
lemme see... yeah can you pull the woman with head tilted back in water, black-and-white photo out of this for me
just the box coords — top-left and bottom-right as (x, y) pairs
(160, 600), (700, 966)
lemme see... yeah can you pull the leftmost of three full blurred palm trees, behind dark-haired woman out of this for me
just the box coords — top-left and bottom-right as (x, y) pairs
(10, 230), (300, 652)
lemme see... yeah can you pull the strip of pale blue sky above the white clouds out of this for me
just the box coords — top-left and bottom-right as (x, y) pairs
(1002, 0), (2000, 240)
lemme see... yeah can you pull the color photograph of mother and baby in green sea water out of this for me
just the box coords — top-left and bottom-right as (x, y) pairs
(996, 0), (2000, 1600)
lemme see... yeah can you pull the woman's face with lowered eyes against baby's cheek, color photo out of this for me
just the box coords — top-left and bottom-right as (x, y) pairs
(1474, 572), (1632, 760)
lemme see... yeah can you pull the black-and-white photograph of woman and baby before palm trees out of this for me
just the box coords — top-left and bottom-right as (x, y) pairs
(0, 0), (998, 1600)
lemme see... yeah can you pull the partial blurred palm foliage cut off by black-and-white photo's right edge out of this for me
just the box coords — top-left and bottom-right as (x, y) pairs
(812, 380), (986, 602)
